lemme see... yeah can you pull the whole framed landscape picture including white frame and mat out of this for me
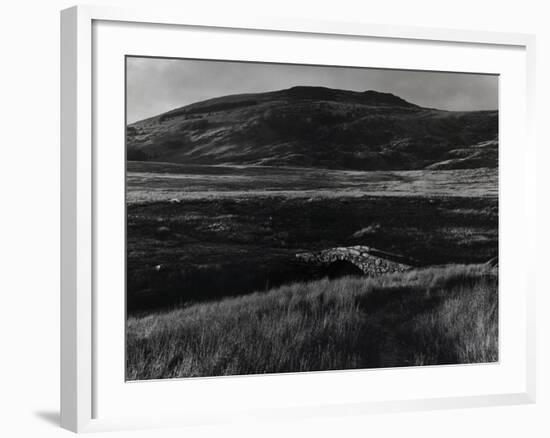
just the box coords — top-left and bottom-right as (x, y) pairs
(61, 7), (535, 431)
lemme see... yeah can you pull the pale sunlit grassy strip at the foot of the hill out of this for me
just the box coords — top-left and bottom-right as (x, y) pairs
(127, 161), (498, 204)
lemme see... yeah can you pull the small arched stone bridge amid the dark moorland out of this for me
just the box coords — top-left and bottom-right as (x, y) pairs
(296, 245), (414, 276)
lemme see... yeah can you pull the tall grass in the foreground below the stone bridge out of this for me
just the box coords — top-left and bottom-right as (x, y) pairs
(126, 265), (498, 380)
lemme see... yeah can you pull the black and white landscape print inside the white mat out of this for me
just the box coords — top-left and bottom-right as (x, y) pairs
(125, 56), (499, 381)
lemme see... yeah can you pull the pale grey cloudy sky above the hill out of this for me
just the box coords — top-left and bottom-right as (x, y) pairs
(126, 57), (498, 123)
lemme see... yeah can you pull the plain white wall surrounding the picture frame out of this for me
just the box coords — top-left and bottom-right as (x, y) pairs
(0, 0), (550, 438)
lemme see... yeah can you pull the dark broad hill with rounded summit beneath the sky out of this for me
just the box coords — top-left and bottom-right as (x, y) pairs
(127, 87), (498, 170)
